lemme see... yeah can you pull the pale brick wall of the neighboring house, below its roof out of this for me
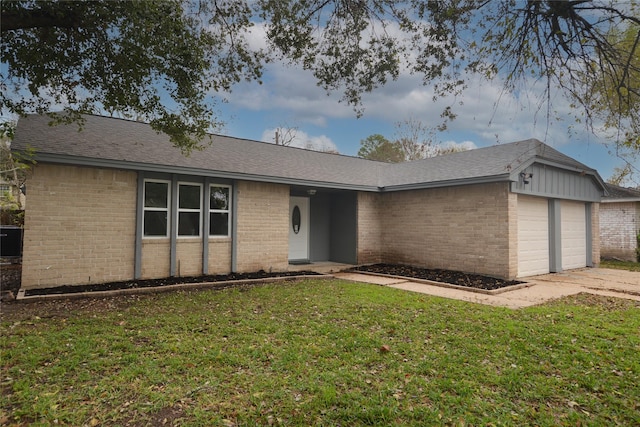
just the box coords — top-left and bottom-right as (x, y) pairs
(599, 202), (640, 261)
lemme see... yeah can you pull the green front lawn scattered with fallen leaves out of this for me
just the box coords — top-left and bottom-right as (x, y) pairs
(0, 280), (640, 426)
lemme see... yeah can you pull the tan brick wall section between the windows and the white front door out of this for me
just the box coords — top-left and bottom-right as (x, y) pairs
(237, 181), (289, 272)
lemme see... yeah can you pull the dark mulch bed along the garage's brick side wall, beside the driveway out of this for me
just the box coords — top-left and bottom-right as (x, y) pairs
(351, 264), (524, 291)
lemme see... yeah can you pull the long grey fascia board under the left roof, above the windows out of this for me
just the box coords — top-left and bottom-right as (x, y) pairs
(36, 153), (380, 192)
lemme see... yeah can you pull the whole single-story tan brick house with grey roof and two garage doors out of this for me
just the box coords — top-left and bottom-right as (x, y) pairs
(12, 115), (605, 290)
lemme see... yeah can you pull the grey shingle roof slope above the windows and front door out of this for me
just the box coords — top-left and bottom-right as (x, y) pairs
(12, 115), (384, 191)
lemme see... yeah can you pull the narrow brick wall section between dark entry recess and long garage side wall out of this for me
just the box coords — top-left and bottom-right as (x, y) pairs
(357, 192), (383, 264)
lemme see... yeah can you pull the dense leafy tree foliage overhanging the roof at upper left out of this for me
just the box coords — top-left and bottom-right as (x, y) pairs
(0, 0), (262, 152)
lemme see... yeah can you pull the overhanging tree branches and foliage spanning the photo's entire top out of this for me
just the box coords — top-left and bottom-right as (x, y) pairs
(0, 0), (640, 154)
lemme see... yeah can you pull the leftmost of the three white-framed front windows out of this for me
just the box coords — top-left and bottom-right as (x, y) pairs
(143, 181), (169, 237)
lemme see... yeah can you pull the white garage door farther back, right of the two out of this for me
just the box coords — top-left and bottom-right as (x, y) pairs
(560, 201), (587, 270)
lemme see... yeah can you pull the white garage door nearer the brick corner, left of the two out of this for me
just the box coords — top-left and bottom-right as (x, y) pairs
(518, 196), (549, 277)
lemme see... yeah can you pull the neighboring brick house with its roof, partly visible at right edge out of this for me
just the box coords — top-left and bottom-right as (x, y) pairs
(600, 184), (640, 261)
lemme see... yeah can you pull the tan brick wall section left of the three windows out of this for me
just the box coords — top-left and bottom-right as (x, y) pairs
(22, 163), (137, 289)
